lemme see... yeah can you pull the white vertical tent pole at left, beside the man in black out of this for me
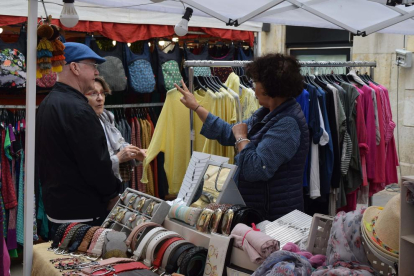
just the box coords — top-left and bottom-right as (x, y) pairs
(23, 0), (38, 276)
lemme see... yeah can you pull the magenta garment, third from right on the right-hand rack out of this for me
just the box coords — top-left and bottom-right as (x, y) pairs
(357, 85), (377, 180)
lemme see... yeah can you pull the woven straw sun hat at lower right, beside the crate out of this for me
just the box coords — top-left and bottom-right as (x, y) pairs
(362, 195), (401, 259)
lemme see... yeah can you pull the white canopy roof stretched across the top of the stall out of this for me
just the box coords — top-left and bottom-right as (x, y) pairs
(76, 0), (414, 35)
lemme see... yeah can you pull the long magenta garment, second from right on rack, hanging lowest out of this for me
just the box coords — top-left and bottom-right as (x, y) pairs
(369, 83), (386, 196)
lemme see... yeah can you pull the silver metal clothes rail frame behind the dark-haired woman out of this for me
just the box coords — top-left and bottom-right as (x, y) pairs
(184, 60), (377, 153)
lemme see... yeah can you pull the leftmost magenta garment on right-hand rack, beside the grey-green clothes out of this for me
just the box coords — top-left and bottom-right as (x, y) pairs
(355, 87), (369, 186)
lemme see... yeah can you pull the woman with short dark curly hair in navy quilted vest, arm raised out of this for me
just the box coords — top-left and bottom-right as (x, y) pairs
(176, 54), (309, 221)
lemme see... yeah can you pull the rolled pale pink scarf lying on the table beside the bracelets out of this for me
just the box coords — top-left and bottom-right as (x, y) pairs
(231, 223), (280, 264)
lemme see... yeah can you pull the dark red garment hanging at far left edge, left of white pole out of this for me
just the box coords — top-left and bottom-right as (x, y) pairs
(1, 128), (17, 209)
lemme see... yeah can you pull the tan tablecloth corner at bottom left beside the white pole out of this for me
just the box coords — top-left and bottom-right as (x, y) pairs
(32, 242), (75, 276)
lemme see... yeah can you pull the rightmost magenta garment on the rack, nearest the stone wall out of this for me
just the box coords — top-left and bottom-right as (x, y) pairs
(380, 85), (399, 184)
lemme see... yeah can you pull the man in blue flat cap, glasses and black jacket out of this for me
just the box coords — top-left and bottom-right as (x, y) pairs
(36, 42), (121, 238)
